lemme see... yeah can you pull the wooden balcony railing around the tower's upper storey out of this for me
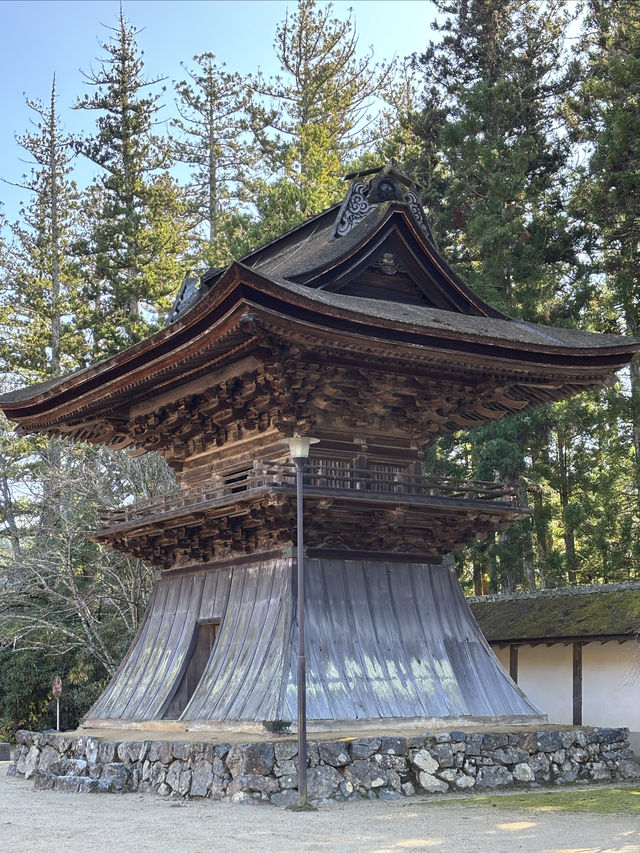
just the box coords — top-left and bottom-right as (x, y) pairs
(101, 459), (518, 527)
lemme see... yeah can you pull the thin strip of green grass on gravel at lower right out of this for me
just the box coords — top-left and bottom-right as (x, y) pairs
(422, 788), (640, 817)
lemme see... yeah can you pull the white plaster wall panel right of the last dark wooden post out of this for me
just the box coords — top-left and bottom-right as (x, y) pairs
(582, 640), (640, 732)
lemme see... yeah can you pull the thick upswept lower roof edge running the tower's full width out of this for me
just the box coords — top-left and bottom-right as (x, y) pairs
(0, 262), (640, 419)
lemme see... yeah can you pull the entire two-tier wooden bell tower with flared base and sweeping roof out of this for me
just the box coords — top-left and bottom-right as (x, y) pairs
(0, 167), (640, 728)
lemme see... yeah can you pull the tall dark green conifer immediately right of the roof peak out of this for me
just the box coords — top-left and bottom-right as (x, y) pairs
(412, 0), (584, 590)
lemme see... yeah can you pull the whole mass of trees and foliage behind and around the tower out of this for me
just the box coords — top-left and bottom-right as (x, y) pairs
(0, 0), (640, 735)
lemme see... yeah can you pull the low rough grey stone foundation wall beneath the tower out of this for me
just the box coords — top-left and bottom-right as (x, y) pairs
(9, 728), (640, 806)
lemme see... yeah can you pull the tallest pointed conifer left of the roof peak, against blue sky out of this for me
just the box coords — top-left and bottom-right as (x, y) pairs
(76, 9), (189, 357)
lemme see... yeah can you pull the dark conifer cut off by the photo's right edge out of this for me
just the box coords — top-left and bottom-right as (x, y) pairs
(568, 0), (640, 492)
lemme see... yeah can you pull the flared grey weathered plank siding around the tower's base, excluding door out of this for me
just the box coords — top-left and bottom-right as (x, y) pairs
(88, 559), (540, 722)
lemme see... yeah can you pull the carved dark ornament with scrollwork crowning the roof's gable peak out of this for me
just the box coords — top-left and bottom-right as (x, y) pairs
(331, 161), (438, 251)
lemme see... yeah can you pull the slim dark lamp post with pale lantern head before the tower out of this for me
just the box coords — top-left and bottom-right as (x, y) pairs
(285, 435), (320, 808)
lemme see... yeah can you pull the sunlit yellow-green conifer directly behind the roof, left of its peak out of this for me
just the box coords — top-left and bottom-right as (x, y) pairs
(250, 0), (390, 236)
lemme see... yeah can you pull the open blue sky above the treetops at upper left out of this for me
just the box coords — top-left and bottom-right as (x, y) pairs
(0, 0), (434, 219)
